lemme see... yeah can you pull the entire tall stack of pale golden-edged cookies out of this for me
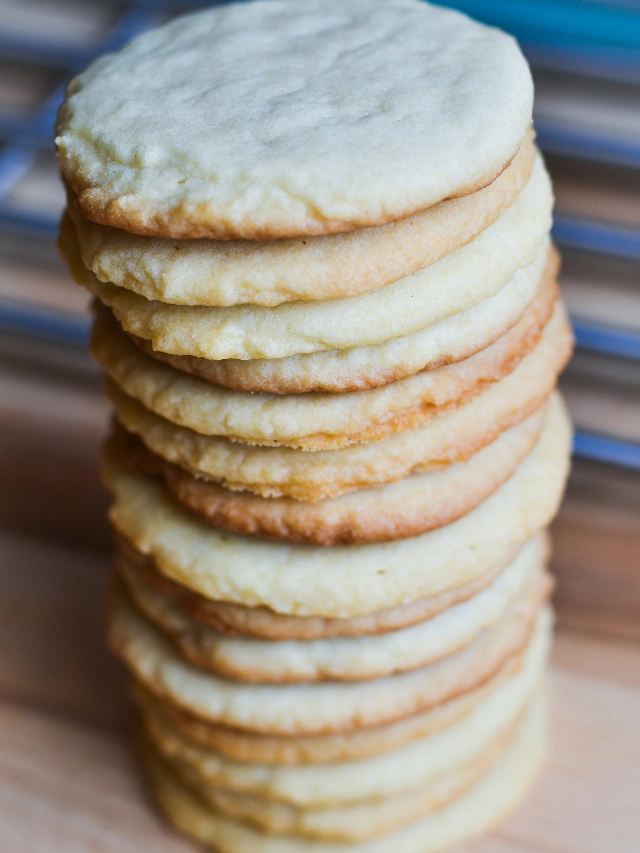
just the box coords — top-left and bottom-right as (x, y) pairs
(57, 0), (571, 853)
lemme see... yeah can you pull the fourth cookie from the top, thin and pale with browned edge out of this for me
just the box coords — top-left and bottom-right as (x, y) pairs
(126, 249), (558, 394)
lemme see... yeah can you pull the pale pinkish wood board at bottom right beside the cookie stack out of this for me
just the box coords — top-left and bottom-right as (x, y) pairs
(499, 664), (640, 853)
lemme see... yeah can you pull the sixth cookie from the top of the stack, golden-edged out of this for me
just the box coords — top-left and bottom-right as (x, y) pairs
(107, 312), (572, 500)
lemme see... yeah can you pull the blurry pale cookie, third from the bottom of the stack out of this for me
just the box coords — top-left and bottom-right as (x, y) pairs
(135, 612), (549, 812)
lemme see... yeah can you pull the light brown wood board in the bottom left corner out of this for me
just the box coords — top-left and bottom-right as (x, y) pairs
(0, 704), (193, 853)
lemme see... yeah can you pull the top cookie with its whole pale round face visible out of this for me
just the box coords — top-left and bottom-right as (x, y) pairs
(57, 0), (533, 239)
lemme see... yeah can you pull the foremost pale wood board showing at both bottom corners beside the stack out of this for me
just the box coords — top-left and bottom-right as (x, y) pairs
(0, 638), (640, 853)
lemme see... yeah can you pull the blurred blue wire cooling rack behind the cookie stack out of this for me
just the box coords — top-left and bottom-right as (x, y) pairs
(0, 0), (640, 470)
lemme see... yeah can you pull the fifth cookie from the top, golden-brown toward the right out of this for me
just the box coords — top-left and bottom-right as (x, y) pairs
(91, 293), (571, 451)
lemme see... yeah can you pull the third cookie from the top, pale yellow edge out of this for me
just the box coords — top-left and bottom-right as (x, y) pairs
(70, 159), (553, 360)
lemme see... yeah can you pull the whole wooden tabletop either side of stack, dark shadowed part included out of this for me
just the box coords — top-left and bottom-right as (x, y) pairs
(0, 531), (640, 853)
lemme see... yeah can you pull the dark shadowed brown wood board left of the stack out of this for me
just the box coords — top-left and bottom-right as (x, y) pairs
(0, 532), (127, 724)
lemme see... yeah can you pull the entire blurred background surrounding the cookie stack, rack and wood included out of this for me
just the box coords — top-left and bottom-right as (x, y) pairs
(0, 0), (640, 853)
